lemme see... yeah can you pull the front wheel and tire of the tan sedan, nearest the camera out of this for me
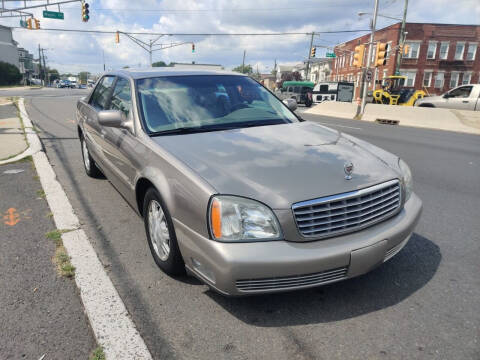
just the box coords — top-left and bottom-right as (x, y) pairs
(143, 188), (185, 276)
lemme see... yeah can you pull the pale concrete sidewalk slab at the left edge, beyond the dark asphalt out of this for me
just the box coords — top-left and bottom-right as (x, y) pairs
(0, 98), (28, 160)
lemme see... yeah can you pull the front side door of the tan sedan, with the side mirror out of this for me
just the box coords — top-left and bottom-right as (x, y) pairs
(102, 76), (138, 200)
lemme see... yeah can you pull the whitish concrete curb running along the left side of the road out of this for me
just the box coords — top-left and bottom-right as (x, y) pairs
(21, 99), (152, 360)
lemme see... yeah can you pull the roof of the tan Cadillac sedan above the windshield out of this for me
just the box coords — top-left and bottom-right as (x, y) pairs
(103, 66), (247, 79)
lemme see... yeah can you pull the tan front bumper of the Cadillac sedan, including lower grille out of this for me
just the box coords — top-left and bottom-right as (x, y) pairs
(174, 194), (422, 296)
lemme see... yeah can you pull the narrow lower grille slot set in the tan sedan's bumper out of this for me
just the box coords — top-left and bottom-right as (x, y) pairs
(236, 267), (347, 292)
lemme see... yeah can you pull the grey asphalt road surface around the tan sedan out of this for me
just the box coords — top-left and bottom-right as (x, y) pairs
(19, 90), (480, 359)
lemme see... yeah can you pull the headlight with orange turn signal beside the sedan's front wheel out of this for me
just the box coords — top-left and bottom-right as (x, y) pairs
(208, 195), (281, 242)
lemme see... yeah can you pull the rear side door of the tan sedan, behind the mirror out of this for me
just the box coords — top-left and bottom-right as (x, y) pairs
(83, 76), (115, 168)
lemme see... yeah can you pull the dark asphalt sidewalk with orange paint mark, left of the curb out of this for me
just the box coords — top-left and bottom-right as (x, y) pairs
(0, 160), (97, 360)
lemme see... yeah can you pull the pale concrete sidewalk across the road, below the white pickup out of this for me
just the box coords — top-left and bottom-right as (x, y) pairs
(305, 101), (480, 135)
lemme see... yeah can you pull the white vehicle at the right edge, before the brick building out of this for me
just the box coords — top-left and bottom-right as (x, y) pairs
(415, 84), (480, 111)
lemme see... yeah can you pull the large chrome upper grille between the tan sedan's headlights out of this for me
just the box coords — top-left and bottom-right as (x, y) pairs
(292, 180), (401, 238)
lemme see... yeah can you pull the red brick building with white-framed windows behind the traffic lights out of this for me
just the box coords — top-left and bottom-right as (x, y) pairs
(330, 23), (480, 97)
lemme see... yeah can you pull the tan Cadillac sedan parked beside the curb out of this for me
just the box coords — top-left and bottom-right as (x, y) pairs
(76, 68), (422, 296)
